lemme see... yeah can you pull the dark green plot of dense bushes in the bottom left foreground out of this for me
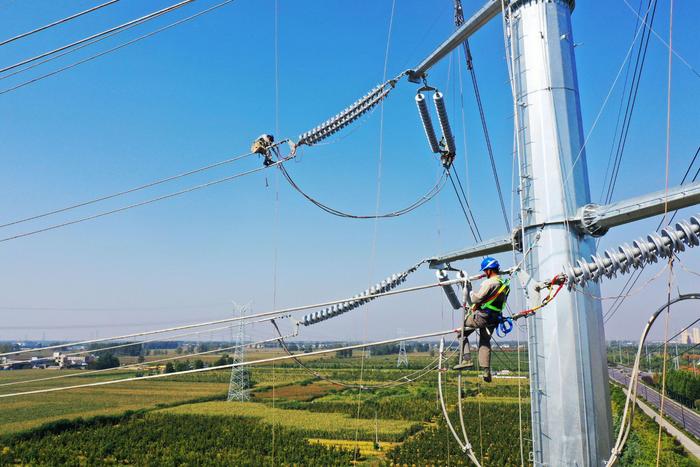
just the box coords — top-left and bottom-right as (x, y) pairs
(0, 413), (353, 466)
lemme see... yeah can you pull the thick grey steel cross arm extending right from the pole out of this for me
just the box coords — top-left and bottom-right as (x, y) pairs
(584, 182), (700, 237)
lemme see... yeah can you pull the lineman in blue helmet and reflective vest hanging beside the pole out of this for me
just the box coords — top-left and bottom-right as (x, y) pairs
(454, 257), (510, 383)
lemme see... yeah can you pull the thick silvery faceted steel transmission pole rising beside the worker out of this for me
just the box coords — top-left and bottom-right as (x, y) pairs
(508, 0), (612, 466)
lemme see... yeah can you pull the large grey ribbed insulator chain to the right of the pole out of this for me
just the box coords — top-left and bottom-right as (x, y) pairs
(564, 215), (700, 289)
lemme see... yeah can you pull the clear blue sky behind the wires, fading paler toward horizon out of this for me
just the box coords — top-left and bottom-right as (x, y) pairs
(0, 0), (700, 339)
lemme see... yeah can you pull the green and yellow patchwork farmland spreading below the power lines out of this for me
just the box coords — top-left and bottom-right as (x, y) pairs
(0, 352), (700, 466)
